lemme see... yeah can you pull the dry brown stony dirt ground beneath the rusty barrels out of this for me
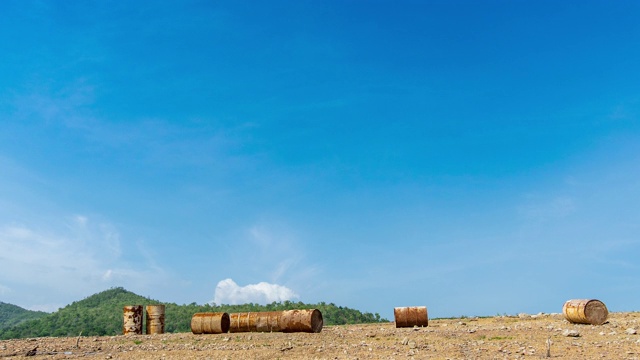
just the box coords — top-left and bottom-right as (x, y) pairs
(0, 312), (640, 359)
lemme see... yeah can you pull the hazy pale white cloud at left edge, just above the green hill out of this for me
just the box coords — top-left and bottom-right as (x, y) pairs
(0, 215), (165, 311)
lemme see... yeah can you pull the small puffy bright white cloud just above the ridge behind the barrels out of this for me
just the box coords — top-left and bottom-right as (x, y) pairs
(213, 279), (298, 304)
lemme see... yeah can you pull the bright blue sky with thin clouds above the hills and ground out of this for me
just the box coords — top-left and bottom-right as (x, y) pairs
(0, 0), (640, 319)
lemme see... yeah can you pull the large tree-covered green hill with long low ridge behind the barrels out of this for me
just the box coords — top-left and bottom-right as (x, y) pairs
(0, 288), (388, 339)
